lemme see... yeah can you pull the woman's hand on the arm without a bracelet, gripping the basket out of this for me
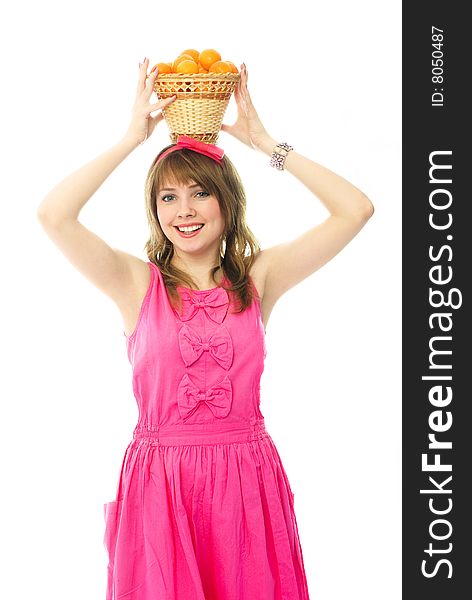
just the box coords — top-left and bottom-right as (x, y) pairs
(124, 58), (177, 145)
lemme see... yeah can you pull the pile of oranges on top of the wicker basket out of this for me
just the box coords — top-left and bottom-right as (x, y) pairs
(151, 48), (239, 75)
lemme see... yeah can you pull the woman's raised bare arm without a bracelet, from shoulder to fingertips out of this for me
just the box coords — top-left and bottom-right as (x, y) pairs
(37, 61), (175, 308)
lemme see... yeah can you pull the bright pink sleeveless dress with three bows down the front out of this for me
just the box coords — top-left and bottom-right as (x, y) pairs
(103, 262), (309, 600)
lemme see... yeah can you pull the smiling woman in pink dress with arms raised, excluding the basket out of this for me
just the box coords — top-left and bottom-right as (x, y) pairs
(38, 59), (373, 600)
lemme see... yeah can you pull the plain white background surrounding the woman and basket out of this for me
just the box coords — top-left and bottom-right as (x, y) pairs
(0, 0), (401, 600)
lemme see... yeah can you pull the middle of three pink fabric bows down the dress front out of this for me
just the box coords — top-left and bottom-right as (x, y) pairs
(179, 324), (233, 370)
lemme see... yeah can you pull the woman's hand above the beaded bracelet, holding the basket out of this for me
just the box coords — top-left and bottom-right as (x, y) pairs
(221, 63), (270, 148)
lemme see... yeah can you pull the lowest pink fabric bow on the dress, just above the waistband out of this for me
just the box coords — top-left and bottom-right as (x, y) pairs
(177, 373), (233, 420)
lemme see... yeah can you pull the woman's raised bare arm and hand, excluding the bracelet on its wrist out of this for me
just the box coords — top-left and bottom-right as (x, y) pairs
(223, 64), (374, 306)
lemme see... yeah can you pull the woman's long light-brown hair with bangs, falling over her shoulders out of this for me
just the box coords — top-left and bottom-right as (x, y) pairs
(144, 144), (260, 312)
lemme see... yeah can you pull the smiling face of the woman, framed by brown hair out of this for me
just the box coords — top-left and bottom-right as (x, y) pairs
(156, 181), (225, 256)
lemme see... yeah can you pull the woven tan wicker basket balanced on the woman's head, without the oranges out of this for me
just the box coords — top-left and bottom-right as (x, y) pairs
(154, 73), (240, 144)
